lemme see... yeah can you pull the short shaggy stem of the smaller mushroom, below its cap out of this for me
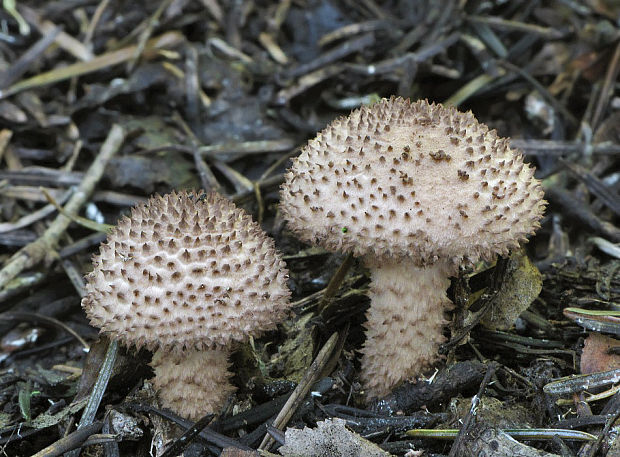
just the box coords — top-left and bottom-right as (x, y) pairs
(151, 349), (235, 421)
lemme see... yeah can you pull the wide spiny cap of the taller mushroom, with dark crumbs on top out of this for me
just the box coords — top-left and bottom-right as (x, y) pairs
(281, 97), (545, 265)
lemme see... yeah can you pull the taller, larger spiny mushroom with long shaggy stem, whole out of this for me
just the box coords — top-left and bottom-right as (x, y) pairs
(281, 98), (545, 398)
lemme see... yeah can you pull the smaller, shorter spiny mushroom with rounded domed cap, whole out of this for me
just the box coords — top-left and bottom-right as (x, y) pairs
(82, 192), (290, 419)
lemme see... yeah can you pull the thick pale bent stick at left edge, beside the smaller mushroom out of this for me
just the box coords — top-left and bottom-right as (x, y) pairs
(0, 124), (125, 289)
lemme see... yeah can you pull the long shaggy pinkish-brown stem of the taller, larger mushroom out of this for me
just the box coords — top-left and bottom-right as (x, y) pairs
(361, 260), (453, 398)
